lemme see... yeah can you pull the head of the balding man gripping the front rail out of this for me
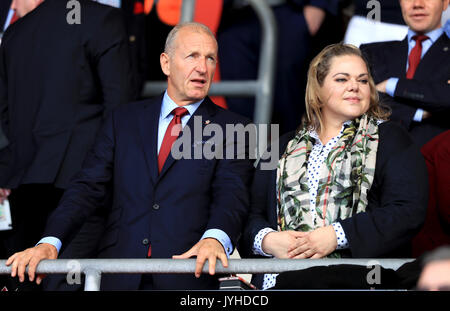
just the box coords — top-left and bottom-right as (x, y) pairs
(160, 27), (217, 106)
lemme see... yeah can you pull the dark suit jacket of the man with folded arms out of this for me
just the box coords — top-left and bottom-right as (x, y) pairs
(360, 33), (450, 146)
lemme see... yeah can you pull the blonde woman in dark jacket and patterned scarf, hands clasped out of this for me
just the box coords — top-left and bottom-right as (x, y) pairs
(241, 43), (428, 289)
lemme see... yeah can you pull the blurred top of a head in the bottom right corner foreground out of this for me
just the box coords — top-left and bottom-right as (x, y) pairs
(417, 246), (450, 291)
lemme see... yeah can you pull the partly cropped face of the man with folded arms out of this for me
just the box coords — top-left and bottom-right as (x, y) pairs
(400, 0), (449, 34)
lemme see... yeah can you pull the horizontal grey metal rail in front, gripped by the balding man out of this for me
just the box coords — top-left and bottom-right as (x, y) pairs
(0, 258), (414, 291)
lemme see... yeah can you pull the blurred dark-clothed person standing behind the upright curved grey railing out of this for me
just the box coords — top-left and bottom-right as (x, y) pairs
(217, 0), (339, 134)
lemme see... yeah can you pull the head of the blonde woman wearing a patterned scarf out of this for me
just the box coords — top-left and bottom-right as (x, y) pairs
(303, 43), (389, 133)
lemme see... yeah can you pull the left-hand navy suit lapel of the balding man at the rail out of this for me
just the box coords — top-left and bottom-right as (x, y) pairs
(138, 96), (162, 184)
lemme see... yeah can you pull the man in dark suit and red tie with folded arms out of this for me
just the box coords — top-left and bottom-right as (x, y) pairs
(361, 0), (450, 145)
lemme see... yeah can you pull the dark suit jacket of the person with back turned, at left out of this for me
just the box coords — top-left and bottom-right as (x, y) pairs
(0, 0), (132, 188)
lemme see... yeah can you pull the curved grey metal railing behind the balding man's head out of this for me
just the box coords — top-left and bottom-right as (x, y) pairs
(142, 0), (277, 124)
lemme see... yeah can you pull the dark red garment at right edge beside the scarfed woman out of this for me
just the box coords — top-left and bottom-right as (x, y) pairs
(413, 131), (450, 257)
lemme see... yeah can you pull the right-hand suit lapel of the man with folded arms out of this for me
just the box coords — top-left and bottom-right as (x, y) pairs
(414, 33), (450, 78)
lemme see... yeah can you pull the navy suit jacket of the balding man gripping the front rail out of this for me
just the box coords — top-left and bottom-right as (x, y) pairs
(44, 97), (253, 290)
